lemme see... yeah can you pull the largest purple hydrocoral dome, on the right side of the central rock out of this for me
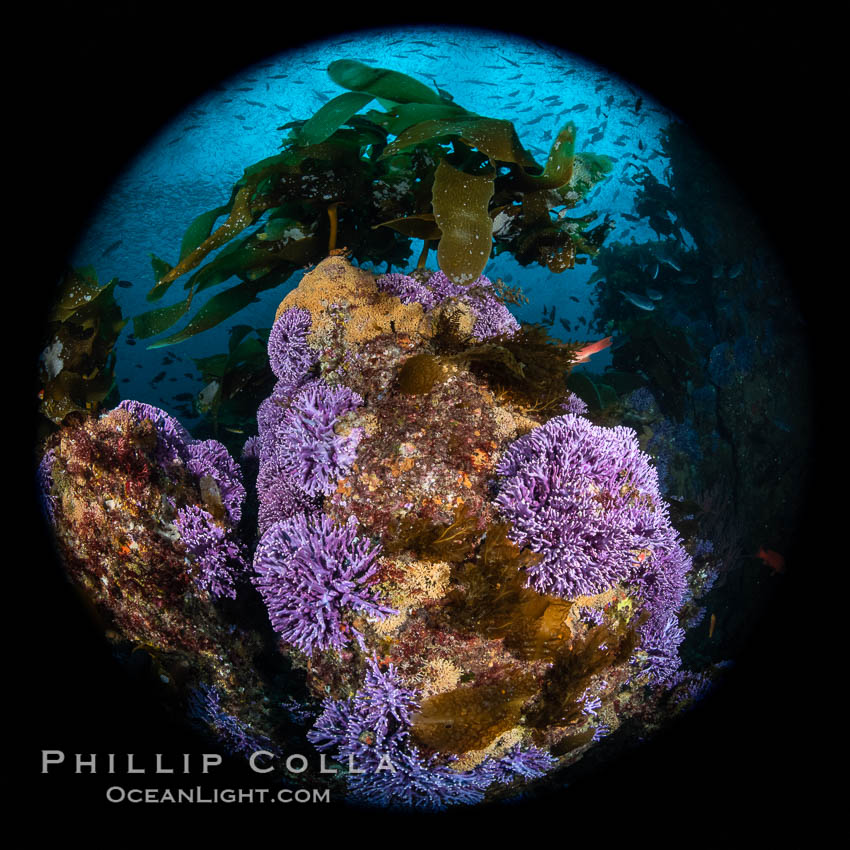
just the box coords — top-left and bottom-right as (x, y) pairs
(495, 414), (670, 598)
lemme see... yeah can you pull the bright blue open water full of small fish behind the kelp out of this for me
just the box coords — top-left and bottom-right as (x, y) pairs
(71, 27), (676, 424)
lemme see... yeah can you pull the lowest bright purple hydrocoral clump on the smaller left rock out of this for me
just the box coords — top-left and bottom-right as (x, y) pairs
(174, 505), (247, 599)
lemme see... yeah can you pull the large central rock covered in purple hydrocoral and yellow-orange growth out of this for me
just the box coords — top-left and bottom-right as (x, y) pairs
(238, 256), (724, 808)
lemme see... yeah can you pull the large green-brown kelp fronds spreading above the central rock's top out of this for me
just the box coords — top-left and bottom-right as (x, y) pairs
(135, 59), (611, 348)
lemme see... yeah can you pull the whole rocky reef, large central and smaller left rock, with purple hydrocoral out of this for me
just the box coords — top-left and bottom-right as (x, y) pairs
(39, 256), (724, 809)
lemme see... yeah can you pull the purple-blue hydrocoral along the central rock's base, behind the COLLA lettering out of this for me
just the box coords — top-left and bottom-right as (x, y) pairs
(307, 659), (556, 809)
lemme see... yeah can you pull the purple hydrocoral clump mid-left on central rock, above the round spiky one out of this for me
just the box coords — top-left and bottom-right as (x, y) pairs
(274, 380), (363, 496)
